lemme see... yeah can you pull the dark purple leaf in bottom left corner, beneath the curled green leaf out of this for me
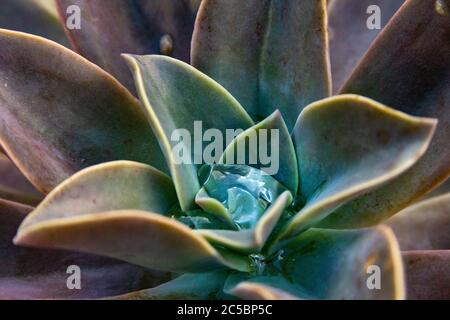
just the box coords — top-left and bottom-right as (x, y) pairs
(0, 200), (171, 300)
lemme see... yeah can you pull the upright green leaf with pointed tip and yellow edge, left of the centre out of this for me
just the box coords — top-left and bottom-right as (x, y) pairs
(125, 55), (253, 211)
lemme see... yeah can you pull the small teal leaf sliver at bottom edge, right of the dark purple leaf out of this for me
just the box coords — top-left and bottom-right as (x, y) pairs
(115, 271), (228, 300)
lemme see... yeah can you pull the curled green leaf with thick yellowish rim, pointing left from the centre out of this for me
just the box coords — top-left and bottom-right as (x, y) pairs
(15, 162), (250, 272)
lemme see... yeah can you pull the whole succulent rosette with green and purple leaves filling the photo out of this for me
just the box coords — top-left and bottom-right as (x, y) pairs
(0, 0), (450, 299)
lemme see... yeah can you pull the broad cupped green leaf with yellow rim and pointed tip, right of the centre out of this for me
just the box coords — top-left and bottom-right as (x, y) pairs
(280, 95), (436, 245)
